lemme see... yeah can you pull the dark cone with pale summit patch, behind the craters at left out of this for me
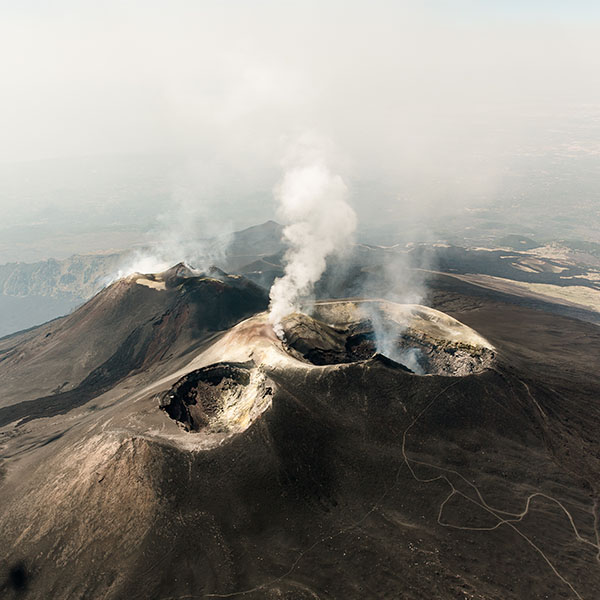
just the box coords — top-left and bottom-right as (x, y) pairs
(0, 265), (267, 423)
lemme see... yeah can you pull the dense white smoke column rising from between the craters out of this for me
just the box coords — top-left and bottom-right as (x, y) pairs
(269, 145), (356, 338)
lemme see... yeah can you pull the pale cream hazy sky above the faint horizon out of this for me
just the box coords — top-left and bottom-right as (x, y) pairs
(0, 0), (600, 258)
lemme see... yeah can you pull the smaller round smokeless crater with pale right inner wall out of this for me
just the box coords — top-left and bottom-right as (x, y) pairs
(159, 363), (273, 433)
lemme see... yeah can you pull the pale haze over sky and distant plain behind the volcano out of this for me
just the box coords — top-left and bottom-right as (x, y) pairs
(0, 0), (600, 262)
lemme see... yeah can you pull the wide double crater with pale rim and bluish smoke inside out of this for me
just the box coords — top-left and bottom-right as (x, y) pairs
(282, 302), (494, 376)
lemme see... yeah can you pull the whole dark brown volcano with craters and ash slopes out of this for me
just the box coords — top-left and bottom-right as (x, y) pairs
(0, 265), (600, 600)
